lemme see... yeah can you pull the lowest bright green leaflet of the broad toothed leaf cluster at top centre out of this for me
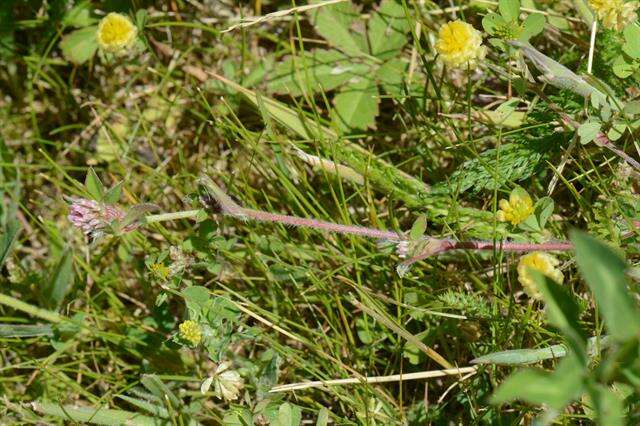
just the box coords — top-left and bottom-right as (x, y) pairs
(333, 78), (379, 131)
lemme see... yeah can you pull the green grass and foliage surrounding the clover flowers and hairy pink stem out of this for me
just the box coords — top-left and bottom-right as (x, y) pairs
(0, 0), (640, 425)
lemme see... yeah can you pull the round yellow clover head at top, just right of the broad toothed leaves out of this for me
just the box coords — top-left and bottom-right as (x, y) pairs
(436, 20), (487, 68)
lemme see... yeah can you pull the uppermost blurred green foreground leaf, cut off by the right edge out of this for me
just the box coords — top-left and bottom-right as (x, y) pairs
(571, 231), (640, 340)
